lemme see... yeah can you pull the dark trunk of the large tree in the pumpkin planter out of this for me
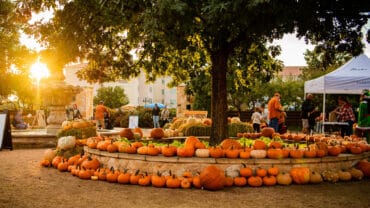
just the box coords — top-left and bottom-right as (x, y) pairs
(209, 51), (228, 146)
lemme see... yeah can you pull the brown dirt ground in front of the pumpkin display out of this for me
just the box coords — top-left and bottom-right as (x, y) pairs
(0, 149), (370, 208)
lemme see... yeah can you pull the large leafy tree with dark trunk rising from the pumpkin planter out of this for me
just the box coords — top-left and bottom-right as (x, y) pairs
(25, 0), (370, 145)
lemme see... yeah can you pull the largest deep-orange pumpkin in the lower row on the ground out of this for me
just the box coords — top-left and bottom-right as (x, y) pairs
(199, 165), (225, 191)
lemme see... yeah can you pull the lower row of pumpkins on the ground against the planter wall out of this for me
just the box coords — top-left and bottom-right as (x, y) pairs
(40, 147), (370, 191)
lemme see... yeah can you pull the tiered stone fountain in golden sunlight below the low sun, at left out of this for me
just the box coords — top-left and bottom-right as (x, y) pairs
(40, 68), (82, 134)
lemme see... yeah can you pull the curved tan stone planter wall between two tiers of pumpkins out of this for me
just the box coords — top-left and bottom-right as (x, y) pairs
(84, 146), (370, 175)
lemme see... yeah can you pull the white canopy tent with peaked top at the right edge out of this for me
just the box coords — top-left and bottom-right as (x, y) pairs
(304, 54), (370, 130)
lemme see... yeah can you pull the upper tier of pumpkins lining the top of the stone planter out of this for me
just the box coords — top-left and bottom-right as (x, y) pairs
(86, 128), (370, 159)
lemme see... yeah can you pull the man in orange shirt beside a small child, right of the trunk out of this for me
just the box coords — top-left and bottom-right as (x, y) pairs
(267, 92), (284, 132)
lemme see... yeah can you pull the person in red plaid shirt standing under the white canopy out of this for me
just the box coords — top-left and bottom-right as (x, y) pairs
(332, 96), (356, 137)
